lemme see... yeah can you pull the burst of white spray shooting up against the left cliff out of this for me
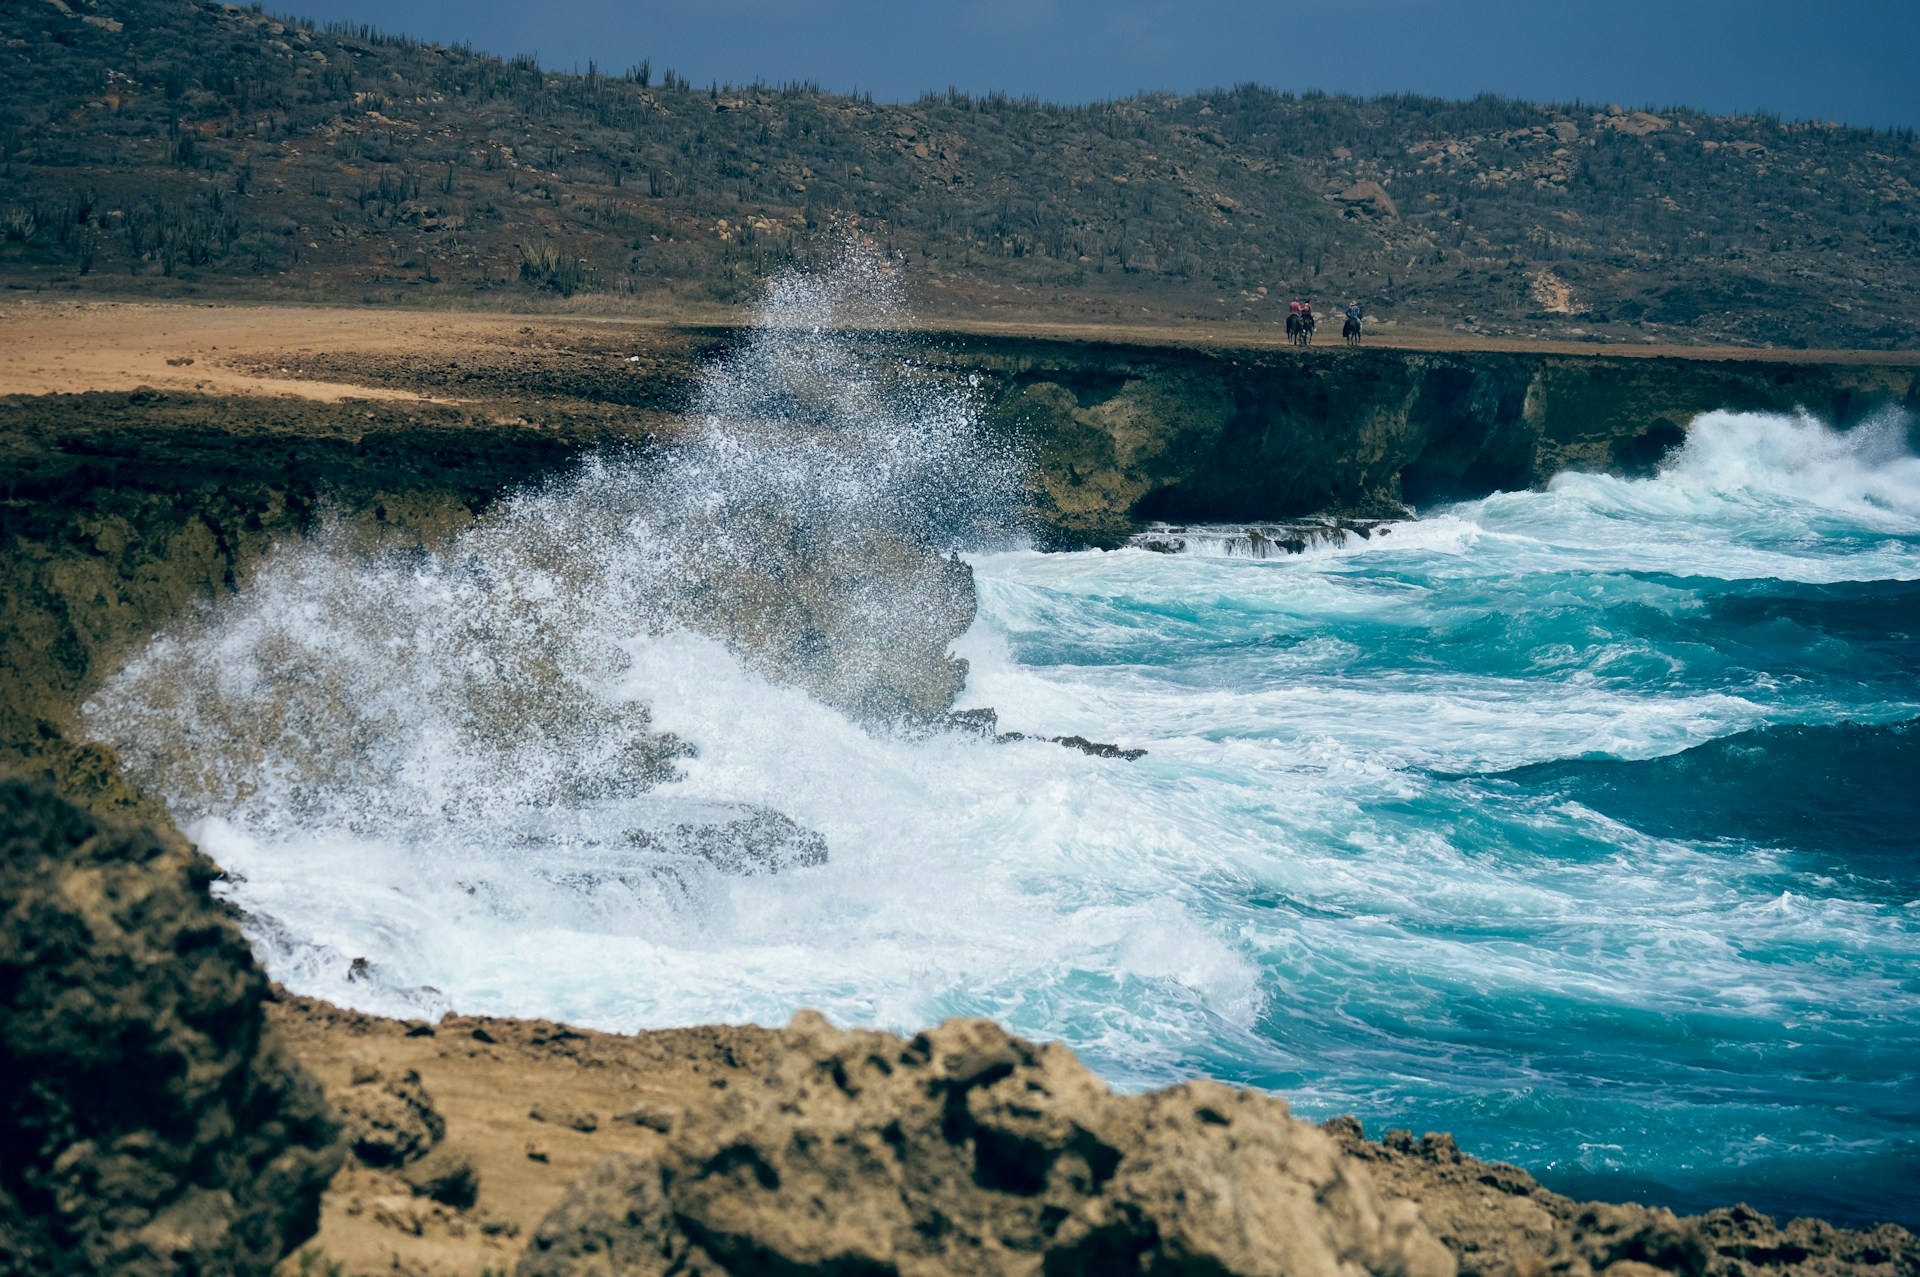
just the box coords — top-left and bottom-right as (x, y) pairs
(84, 248), (1021, 902)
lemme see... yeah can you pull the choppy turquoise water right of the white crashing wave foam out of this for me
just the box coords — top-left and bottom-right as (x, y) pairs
(967, 415), (1920, 1223)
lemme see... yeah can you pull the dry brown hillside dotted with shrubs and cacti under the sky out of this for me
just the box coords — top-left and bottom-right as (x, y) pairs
(0, 0), (1920, 349)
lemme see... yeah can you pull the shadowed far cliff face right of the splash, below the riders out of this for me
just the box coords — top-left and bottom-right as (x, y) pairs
(925, 334), (1920, 545)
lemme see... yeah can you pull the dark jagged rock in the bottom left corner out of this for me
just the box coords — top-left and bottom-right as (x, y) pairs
(0, 780), (342, 1277)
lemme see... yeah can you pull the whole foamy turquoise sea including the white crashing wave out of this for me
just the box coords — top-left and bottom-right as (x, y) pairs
(78, 291), (1920, 1221)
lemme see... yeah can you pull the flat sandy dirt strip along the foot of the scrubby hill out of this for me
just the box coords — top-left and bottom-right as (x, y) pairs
(0, 301), (1920, 403)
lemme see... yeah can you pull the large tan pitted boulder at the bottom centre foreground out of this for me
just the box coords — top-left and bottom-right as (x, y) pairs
(518, 1012), (1455, 1277)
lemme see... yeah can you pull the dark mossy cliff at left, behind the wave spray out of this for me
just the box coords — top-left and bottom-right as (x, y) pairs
(0, 392), (645, 828)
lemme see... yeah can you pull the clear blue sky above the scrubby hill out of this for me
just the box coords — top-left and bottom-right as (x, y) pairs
(284, 0), (1920, 127)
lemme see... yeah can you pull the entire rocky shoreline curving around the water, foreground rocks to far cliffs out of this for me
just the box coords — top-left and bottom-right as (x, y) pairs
(0, 307), (1920, 1277)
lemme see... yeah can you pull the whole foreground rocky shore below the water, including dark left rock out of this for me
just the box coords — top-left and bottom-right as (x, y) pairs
(0, 782), (1920, 1277)
